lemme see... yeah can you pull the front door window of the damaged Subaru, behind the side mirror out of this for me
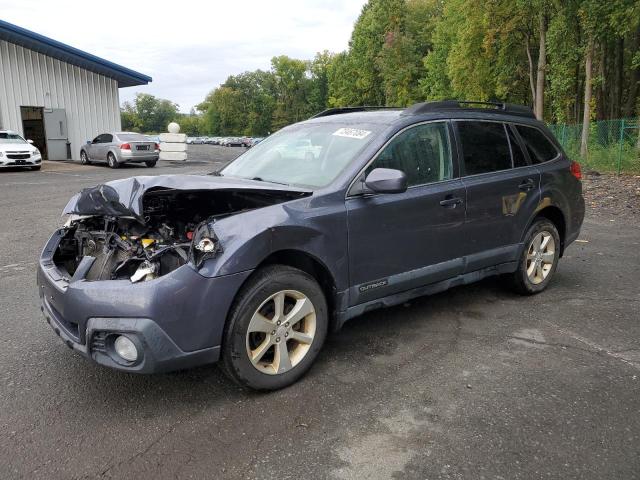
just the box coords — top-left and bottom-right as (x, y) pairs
(366, 122), (452, 187)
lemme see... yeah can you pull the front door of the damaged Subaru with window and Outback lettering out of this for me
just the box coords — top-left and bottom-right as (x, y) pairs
(346, 122), (465, 306)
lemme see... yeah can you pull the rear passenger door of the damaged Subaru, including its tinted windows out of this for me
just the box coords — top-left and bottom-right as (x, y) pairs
(455, 120), (540, 272)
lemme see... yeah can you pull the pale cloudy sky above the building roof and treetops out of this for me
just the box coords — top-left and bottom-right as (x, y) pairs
(0, 0), (365, 112)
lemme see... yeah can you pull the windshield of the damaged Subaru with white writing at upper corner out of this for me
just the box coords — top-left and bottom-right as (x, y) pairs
(220, 123), (384, 188)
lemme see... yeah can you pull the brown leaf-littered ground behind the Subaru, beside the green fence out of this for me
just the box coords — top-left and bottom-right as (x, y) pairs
(582, 174), (640, 219)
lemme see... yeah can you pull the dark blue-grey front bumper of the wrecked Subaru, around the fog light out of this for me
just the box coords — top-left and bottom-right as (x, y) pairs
(38, 229), (251, 373)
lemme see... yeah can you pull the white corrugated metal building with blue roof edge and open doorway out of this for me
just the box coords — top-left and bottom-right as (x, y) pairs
(0, 20), (151, 160)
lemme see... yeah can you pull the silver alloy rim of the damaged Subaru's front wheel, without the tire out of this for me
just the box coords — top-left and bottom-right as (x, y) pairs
(246, 290), (316, 375)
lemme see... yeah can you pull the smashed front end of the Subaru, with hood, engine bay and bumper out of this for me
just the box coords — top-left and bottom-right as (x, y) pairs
(38, 176), (310, 373)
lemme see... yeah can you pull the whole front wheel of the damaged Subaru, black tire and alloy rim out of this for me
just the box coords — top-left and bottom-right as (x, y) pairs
(222, 265), (329, 390)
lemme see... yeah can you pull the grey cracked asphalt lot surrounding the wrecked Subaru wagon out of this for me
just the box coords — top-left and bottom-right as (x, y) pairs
(0, 145), (640, 479)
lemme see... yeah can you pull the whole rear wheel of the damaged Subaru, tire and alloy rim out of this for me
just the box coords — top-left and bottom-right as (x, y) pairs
(506, 218), (560, 295)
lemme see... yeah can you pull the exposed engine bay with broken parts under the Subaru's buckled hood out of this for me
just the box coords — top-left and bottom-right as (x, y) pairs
(54, 188), (308, 283)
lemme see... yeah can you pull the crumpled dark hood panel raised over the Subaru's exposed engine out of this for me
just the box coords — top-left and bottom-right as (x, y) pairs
(62, 175), (311, 221)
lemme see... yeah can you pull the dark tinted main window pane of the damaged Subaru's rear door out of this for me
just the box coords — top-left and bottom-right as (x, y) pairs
(458, 121), (511, 175)
